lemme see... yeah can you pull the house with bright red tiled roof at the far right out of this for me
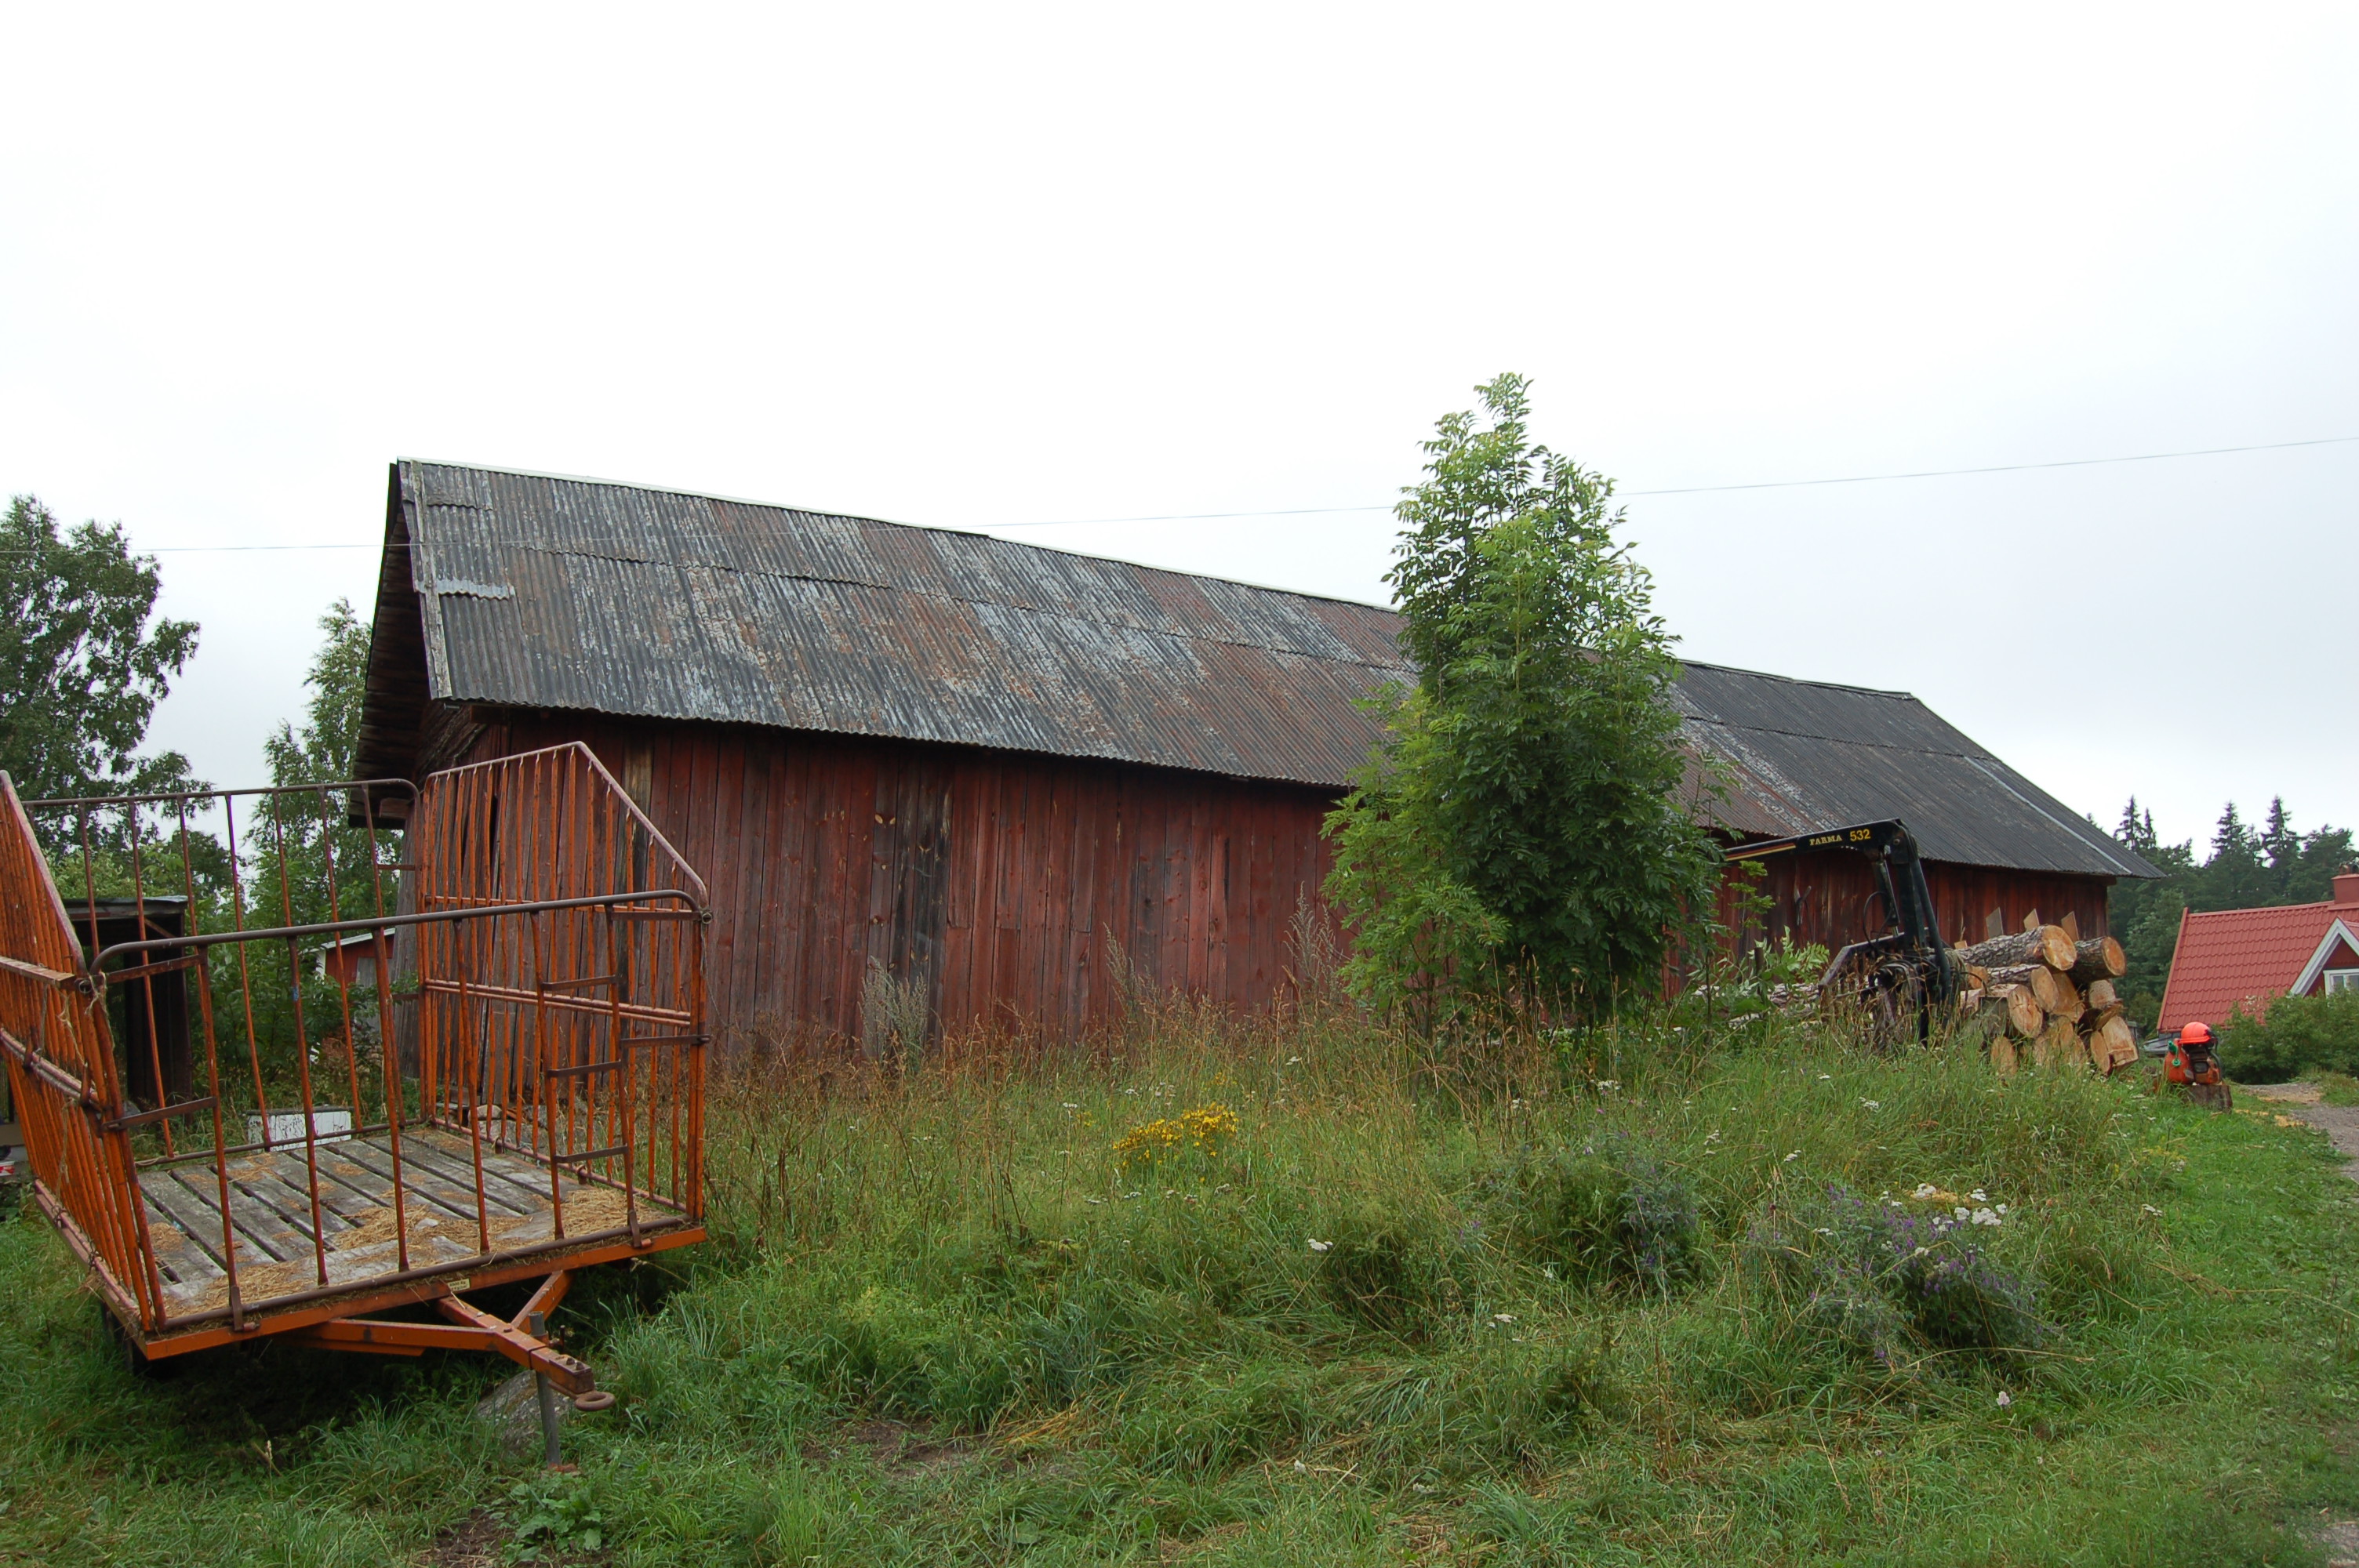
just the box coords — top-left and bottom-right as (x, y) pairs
(2161, 873), (2359, 1033)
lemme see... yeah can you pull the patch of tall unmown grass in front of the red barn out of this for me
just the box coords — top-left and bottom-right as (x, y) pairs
(665, 990), (2154, 1476)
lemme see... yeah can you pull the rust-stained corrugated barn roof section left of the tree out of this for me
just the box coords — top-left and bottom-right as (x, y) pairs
(396, 462), (1408, 786)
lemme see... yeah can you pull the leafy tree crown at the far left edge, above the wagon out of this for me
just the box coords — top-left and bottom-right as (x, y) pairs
(0, 495), (196, 800)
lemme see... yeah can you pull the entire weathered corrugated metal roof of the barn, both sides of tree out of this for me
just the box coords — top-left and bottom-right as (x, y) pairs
(363, 462), (2156, 877)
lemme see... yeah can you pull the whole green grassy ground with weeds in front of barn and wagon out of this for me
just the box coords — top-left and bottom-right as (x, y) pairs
(0, 1011), (2359, 1566)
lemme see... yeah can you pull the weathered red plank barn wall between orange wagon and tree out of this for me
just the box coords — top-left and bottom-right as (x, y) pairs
(450, 714), (1333, 1042)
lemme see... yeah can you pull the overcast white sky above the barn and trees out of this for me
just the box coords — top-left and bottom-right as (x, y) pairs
(0, 5), (2359, 858)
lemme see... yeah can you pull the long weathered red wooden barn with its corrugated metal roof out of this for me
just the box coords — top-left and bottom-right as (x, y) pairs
(356, 462), (2151, 1044)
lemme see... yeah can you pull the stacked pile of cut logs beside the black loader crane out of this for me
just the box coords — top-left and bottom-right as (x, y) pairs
(1951, 924), (2137, 1073)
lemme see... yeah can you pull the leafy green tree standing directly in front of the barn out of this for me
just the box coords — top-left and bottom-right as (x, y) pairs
(1325, 375), (1720, 1028)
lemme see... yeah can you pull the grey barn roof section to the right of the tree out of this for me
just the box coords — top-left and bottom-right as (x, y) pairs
(1677, 665), (2161, 877)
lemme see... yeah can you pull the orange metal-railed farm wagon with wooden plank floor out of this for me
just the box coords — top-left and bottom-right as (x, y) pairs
(0, 745), (710, 1462)
